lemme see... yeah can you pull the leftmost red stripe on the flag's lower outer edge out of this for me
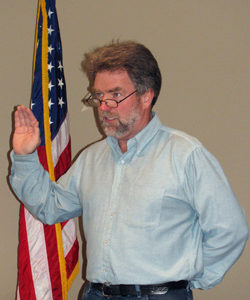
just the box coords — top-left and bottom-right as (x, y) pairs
(18, 204), (36, 300)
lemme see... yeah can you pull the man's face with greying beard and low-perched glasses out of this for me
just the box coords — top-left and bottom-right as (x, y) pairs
(93, 70), (149, 145)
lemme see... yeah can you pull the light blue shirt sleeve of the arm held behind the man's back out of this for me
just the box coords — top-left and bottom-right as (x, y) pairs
(186, 147), (248, 289)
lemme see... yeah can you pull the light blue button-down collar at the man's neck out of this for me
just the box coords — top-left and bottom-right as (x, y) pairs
(107, 112), (162, 157)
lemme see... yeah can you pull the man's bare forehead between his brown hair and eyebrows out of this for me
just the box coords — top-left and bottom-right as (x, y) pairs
(93, 70), (134, 92)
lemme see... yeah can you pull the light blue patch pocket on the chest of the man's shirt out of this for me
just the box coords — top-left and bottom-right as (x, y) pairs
(124, 184), (164, 228)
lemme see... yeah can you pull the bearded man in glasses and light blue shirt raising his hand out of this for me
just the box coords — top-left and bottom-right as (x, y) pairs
(10, 42), (248, 300)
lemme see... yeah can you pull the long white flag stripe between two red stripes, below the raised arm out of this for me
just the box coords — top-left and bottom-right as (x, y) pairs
(25, 209), (53, 300)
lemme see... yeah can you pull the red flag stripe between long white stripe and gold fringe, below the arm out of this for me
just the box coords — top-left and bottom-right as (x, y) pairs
(43, 225), (62, 299)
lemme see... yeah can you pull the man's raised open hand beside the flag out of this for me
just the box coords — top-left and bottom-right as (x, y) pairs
(12, 105), (41, 155)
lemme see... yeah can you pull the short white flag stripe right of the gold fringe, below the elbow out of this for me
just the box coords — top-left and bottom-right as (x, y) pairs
(62, 219), (76, 257)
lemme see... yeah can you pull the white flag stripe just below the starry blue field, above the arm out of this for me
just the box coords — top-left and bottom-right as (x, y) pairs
(52, 113), (69, 166)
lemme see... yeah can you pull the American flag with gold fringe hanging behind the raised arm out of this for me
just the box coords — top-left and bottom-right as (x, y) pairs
(17, 0), (79, 300)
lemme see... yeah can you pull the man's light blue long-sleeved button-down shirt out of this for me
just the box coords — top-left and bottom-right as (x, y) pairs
(10, 115), (248, 289)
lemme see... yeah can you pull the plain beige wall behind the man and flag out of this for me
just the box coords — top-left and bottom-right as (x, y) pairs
(0, 0), (250, 300)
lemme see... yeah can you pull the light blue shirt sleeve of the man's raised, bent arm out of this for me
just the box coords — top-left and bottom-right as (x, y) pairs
(10, 151), (82, 224)
